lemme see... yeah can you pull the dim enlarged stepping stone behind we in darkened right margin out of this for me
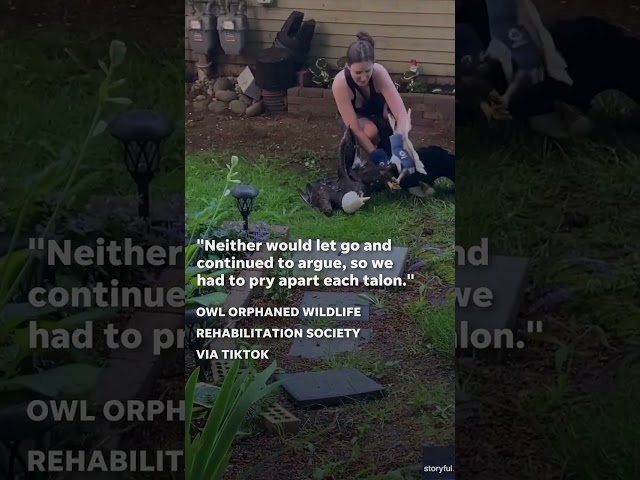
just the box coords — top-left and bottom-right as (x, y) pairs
(456, 255), (529, 350)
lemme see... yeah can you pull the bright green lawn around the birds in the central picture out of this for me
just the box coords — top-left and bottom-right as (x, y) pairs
(185, 153), (455, 355)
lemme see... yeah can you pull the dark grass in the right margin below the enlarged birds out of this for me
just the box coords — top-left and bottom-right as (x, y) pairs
(456, 94), (640, 479)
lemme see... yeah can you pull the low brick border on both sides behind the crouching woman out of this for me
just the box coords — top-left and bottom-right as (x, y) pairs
(287, 86), (455, 125)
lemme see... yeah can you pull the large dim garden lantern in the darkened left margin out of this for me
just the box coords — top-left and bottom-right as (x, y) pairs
(109, 110), (173, 218)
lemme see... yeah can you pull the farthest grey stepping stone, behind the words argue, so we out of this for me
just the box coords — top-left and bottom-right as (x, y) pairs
(292, 242), (409, 280)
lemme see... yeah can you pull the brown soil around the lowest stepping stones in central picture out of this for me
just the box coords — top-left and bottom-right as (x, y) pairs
(224, 289), (455, 480)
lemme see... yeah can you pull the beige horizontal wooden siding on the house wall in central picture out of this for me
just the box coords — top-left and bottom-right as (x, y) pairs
(185, 0), (455, 78)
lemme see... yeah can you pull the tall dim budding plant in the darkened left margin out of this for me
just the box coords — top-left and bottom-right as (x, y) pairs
(0, 40), (132, 397)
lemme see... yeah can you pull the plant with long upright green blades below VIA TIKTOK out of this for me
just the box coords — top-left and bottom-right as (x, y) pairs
(184, 360), (280, 480)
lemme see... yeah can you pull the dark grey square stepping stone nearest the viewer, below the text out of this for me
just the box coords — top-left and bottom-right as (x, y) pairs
(278, 368), (385, 408)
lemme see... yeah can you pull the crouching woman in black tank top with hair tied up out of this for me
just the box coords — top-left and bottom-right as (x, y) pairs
(332, 32), (407, 163)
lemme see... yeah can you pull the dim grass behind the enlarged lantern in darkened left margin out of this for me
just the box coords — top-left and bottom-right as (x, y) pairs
(0, 29), (184, 204)
